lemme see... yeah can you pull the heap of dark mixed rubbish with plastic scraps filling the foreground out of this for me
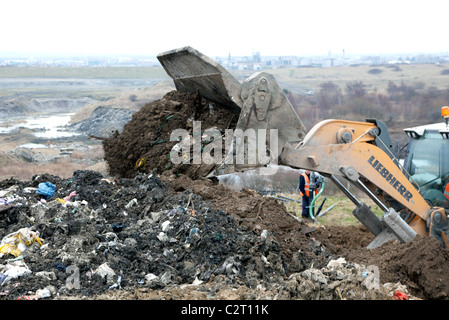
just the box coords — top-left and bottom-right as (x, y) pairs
(0, 170), (407, 299)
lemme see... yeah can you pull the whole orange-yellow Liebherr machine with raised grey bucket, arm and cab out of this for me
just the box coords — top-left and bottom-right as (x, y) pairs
(158, 47), (449, 249)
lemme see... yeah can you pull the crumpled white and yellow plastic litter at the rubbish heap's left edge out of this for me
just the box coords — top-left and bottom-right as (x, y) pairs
(0, 228), (42, 257)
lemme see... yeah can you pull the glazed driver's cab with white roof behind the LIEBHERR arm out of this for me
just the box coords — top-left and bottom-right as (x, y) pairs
(404, 113), (449, 208)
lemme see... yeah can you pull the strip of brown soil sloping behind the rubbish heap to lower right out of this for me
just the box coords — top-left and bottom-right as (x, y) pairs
(163, 172), (449, 299)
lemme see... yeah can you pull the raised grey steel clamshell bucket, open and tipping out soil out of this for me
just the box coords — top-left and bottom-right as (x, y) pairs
(157, 47), (306, 177)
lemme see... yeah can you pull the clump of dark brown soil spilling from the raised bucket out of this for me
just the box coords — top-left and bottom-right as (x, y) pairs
(103, 91), (238, 179)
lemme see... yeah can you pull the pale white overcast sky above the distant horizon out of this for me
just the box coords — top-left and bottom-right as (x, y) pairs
(0, 0), (449, 57)
